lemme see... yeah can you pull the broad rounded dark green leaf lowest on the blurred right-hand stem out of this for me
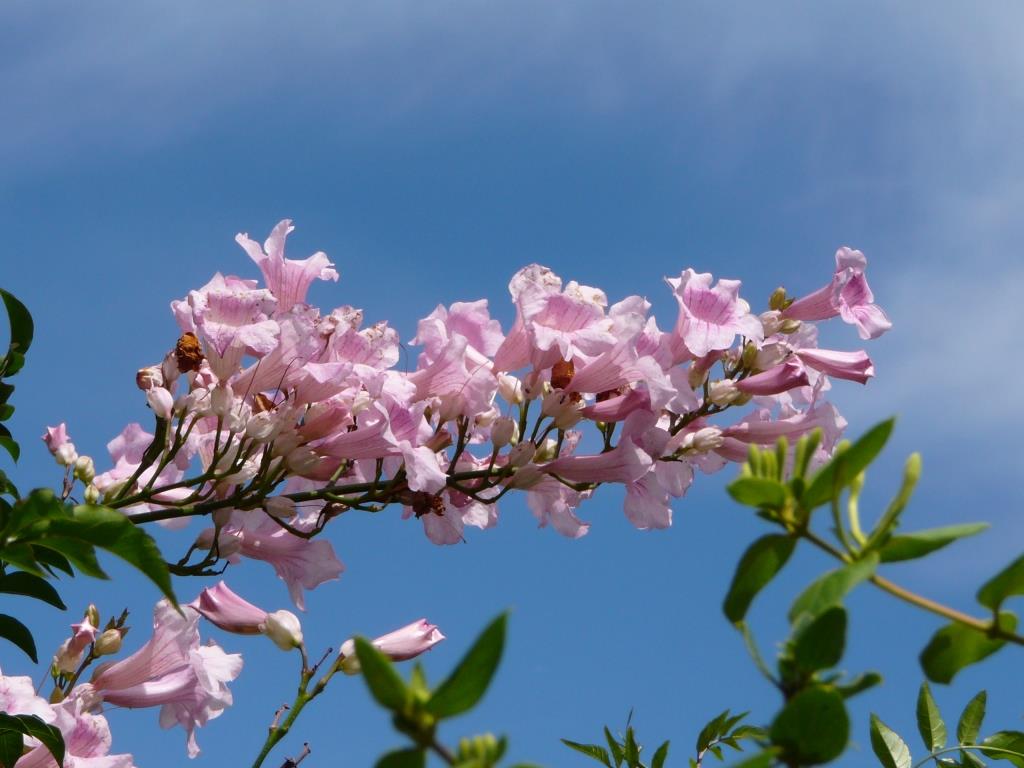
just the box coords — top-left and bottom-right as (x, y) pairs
(770, 686), (850, 765)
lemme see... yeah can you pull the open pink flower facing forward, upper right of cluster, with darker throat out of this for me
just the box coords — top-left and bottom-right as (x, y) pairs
(666, 269), (763, 357)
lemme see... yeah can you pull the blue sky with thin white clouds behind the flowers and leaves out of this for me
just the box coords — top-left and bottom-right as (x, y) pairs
(0, 0), (1024, 768)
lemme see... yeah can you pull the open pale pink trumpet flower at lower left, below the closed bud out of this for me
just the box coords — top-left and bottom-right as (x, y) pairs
(86, 600), (242, 757)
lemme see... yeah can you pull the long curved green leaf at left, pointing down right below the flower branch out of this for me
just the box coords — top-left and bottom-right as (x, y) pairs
(49, 504), (178, 605)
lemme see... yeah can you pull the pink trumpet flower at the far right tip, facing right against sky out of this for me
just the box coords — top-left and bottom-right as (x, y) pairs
(781, 247), (893, 339)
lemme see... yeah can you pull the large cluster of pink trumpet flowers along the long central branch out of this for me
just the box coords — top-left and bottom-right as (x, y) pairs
(45, 220), (891, 608)
